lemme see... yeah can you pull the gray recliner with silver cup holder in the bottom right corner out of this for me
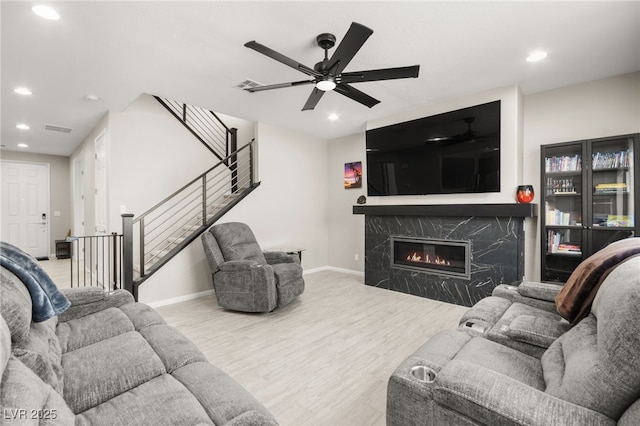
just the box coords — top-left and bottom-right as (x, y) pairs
(387, 256), (640, 426)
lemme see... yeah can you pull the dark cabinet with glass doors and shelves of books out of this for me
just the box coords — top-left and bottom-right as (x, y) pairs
(540, 134), (640, 282)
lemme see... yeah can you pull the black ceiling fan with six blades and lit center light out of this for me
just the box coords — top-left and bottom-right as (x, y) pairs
(244, 22), (420, 111)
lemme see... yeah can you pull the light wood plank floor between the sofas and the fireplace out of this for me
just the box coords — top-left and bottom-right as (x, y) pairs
(158, 271), (467, 426)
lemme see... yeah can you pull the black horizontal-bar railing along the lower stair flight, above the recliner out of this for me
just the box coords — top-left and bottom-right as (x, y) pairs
(122, 141), (259, 300)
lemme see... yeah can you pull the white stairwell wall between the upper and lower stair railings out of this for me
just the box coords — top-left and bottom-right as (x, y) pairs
(108, 95), (220, 232)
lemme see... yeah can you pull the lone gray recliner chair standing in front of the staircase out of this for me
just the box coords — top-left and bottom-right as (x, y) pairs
(201, 222), (304, 312)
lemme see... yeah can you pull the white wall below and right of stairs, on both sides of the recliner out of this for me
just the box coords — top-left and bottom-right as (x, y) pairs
(140, 123), (328, 303)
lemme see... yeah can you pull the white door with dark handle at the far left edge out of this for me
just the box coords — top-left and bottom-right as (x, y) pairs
(0, 161), (50, 257)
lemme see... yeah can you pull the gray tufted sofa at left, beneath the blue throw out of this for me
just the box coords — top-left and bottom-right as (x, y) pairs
(0, 243), (277, 426)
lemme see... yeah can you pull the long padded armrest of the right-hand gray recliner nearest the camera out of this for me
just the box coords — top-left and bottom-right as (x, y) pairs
(433, 360), (616, 425)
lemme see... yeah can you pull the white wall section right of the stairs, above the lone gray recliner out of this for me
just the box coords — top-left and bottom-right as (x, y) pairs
(212, 123), (328, 269)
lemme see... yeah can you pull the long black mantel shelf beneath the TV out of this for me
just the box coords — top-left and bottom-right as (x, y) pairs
(353, 203), (538, 217)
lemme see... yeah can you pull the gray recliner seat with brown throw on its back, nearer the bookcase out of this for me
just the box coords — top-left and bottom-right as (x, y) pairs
(460, 237), (640, 358)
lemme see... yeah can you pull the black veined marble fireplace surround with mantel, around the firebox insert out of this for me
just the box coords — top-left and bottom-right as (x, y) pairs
(353, 204), (537, 306)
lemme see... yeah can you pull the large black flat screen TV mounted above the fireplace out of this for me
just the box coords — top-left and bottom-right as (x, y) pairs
(366, 101), (500, 196)
